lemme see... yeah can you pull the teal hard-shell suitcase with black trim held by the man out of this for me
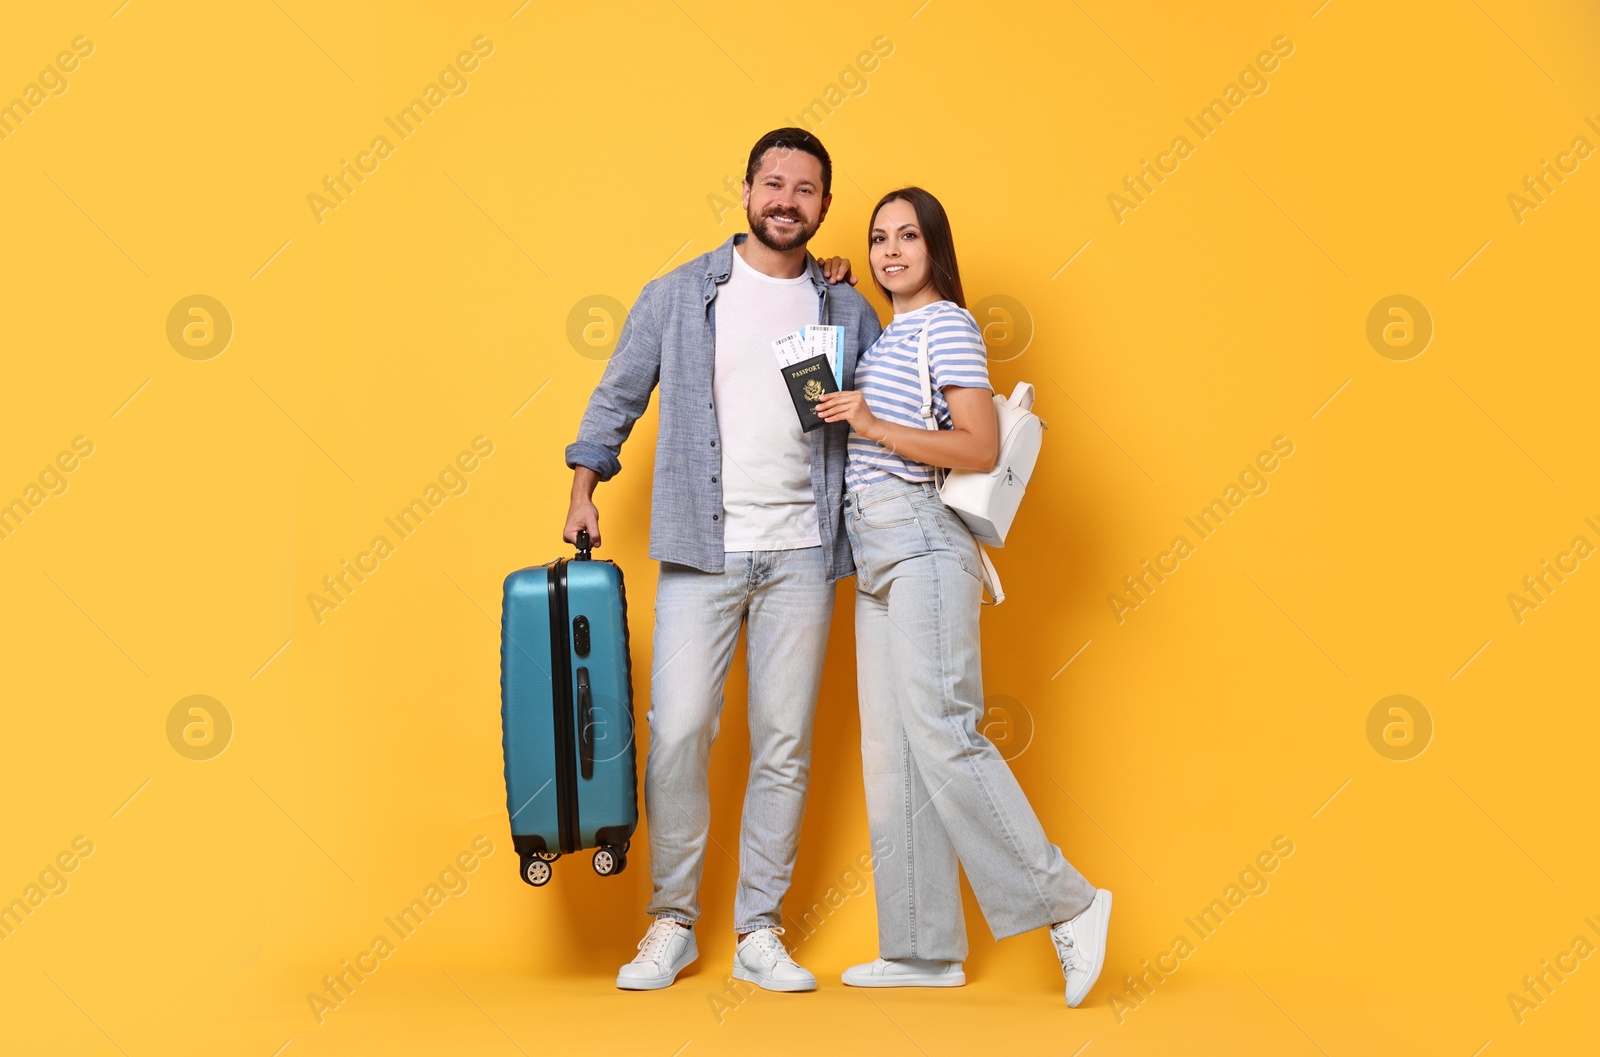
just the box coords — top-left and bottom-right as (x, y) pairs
(501, 532), (638, 886)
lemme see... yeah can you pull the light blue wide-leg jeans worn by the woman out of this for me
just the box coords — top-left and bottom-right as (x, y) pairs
(845, 480), (1094, 961)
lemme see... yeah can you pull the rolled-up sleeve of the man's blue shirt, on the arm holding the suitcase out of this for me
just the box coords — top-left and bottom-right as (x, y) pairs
(566, 283), (661, 481)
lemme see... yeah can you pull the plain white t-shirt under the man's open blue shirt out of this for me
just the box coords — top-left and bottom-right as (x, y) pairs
(712, 248), (822, 550)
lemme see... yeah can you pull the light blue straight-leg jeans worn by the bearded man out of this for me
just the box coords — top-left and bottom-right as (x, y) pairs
(645, 545), (834, 932)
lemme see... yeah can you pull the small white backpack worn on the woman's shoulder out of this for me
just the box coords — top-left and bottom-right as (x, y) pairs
(917, 326), (1045, 606)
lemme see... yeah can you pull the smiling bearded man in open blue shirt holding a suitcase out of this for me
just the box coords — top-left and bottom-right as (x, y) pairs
(565, 128), (882, 991)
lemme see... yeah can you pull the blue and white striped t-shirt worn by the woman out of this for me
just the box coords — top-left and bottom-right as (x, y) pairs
(845, 301), (992, 489)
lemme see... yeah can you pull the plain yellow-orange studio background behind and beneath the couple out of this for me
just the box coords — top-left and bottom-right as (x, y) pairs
(0, 0), (1600, 1057)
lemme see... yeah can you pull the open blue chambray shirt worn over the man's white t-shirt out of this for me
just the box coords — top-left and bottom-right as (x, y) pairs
(566, 232), (883, 582)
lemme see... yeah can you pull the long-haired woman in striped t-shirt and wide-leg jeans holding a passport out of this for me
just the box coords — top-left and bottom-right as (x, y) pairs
(816, 187), (1110, 1006)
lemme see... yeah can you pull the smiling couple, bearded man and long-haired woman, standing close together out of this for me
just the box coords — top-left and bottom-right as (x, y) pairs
(565, 128), (1110, 1006)
